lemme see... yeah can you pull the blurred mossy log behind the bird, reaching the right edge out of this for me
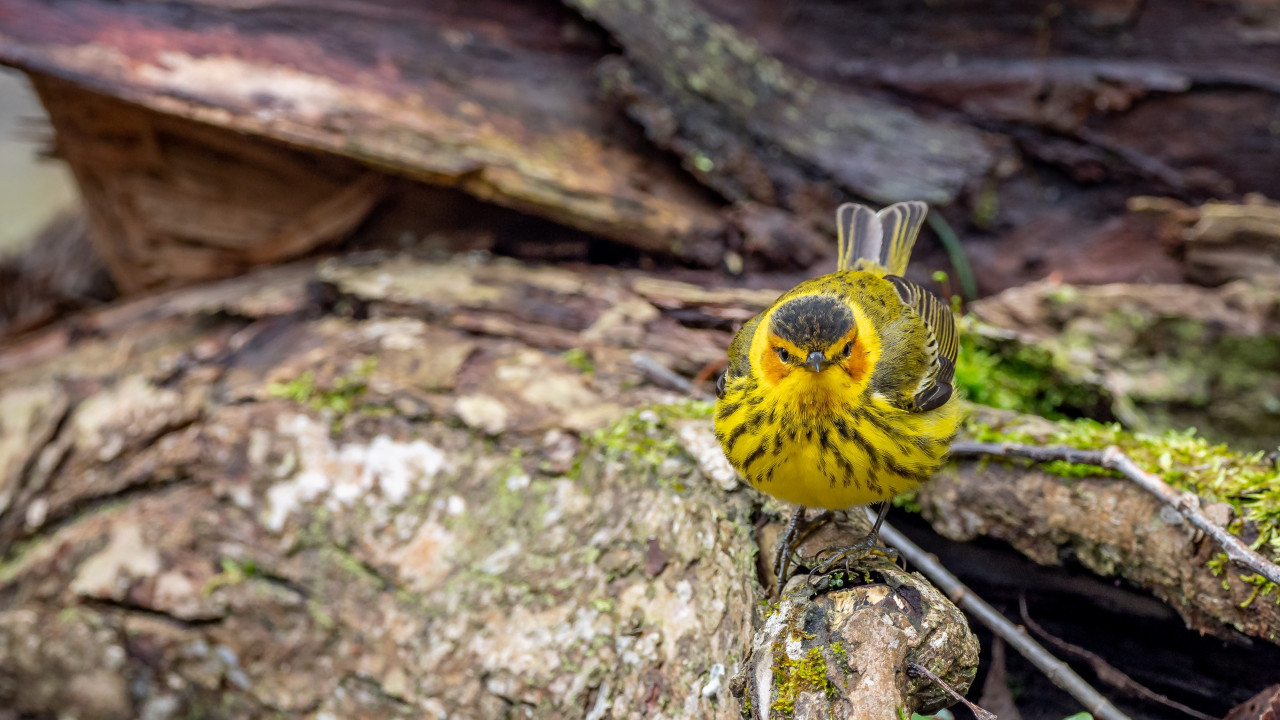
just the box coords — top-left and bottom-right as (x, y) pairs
(961, 274), (1280, 451)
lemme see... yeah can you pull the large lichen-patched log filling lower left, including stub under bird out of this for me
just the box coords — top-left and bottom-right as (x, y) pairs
(0, 255), (977, 719)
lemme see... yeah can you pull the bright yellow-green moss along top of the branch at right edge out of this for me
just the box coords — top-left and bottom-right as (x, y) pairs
(966, 420), (1280, 594)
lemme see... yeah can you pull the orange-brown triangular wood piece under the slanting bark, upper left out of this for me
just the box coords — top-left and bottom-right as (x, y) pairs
(32, 76), (387, 295)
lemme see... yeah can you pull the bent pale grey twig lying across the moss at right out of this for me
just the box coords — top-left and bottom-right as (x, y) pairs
(951, 441), (1280, 583)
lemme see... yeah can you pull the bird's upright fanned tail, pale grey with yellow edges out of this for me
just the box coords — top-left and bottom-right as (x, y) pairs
(836, 200), (929, 275)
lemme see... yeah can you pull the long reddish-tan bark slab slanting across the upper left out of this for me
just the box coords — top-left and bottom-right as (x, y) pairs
(0, 0), (724, 271)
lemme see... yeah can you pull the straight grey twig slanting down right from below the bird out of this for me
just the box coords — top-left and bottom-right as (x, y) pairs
(881, 512), (1129, 720)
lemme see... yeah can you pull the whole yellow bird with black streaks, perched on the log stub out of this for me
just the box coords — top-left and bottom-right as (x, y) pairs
(716, 202), (959, 582)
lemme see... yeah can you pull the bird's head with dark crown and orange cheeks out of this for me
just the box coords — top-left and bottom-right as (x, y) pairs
(756, 295), (867, 382)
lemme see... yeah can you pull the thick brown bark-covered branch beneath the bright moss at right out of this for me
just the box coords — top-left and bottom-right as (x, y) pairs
(916, 411), (1280, 644)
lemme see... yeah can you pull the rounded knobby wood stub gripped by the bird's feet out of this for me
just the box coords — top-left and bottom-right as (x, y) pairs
(730, 514), (978, 720)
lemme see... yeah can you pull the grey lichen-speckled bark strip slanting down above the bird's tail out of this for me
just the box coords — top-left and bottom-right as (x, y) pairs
(568, 0), (995, 208)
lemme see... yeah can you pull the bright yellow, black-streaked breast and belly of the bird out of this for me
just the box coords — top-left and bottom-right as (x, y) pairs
(716, 384), (959, 510)
